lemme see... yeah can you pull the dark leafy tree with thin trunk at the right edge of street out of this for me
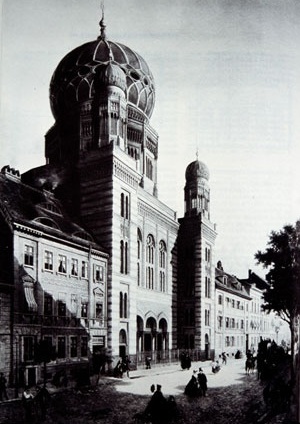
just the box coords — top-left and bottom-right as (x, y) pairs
(255, 220), (300, 378)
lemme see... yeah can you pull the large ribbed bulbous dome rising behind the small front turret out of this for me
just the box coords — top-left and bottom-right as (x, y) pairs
(50, 37), (155, 119)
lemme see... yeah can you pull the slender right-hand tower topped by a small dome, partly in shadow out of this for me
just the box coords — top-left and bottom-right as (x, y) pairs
(177, 155), (217, 359)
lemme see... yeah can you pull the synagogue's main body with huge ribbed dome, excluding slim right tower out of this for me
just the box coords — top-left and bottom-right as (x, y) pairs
(23, 13), (178, 360)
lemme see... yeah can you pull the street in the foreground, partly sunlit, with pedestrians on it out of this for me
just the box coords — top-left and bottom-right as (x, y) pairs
(0, 360), (287, 424)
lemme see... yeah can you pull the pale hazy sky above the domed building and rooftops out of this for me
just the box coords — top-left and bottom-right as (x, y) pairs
(0, 0), (300, 278)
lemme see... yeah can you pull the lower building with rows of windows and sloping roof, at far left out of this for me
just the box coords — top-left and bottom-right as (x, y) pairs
(0, 166), (108, 386)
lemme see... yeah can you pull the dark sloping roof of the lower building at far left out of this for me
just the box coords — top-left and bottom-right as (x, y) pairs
(0, 166), (107, 251)
